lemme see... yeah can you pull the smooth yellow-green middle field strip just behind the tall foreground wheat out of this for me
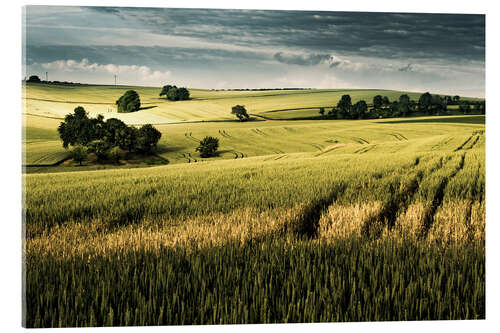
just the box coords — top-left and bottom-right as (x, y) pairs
(24, 106), (485, 167)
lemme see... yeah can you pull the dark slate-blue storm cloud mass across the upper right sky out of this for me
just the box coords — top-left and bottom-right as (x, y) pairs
(86, 7), (485, 61)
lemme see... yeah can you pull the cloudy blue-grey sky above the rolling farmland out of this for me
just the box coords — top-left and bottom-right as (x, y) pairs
(23, 6), (485, 97)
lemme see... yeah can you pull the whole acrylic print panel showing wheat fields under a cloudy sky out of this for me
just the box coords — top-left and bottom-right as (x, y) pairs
(23, 6), (485, 327)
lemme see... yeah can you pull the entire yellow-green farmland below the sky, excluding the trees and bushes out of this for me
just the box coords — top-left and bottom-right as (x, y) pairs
(23, 85), (485, 327)
